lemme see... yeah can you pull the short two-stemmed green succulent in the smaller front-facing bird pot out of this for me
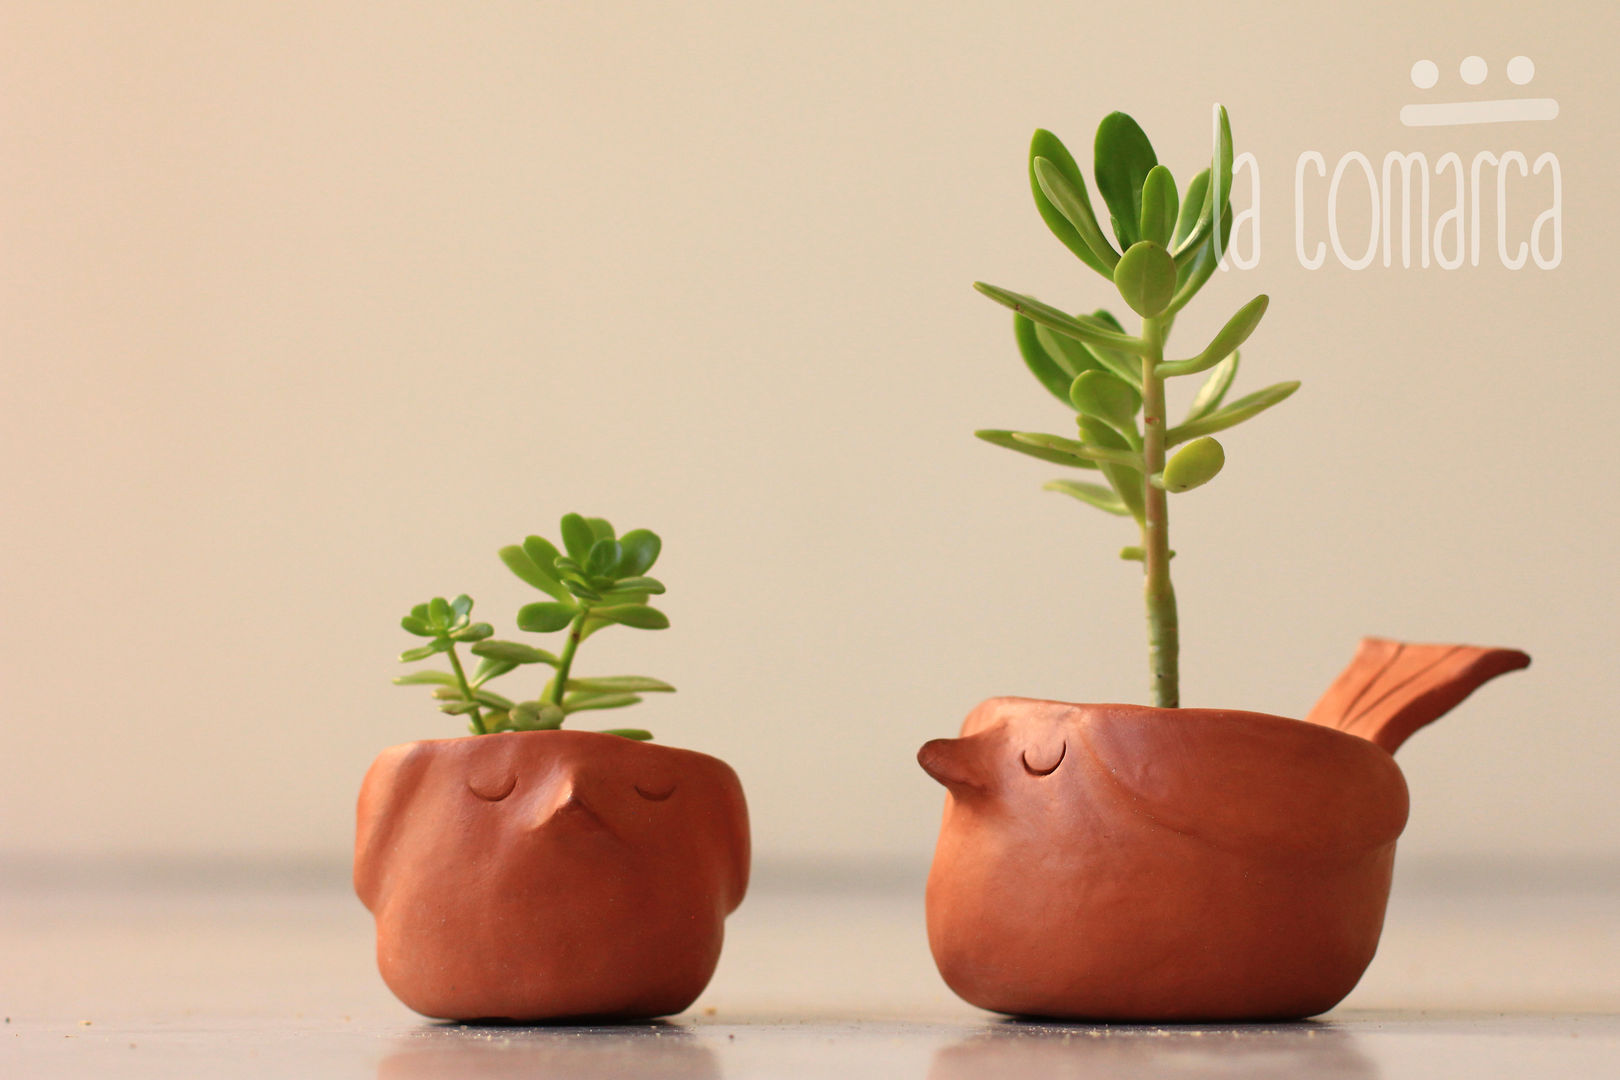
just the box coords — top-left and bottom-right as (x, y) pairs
(394, 513), (674, 738)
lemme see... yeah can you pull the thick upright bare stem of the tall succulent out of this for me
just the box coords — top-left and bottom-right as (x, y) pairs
(1142, 317), (1181, 709)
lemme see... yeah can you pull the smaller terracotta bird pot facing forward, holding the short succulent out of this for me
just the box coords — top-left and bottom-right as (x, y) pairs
(355, 730), (748, 1020)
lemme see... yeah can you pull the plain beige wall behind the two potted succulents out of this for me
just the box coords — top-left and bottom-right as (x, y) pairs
(0, 2), (1620, 858)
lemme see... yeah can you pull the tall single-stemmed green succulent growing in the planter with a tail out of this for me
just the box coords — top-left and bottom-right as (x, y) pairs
(975, 105), (1299, 708)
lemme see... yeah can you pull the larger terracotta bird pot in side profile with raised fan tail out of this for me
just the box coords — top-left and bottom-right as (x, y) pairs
(917, 638), (1529, 1020)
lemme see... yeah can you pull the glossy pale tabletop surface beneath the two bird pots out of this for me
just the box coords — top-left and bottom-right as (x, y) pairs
(0, 863), (1620, 1080)
